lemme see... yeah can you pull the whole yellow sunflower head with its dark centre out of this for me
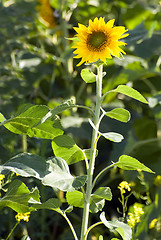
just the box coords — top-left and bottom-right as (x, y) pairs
(72, 17), (129, 66)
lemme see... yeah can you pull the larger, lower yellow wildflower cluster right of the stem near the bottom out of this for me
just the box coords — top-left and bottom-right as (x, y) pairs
(127, 205), (144, 228)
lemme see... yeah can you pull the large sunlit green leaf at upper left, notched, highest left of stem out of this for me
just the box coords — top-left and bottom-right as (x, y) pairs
(3, 105), (63, 139)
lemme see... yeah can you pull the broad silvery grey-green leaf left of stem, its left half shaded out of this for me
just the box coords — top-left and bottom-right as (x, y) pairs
(0, 153), (86, 191)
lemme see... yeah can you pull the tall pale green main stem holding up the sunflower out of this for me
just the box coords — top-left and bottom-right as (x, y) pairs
(80, 65), (103, 240)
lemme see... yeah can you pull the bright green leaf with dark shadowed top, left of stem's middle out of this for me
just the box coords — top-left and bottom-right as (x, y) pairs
(52, 135), (84, 165)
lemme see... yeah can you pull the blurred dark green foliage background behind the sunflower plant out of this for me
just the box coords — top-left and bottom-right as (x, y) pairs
(0, 0), (161, 240)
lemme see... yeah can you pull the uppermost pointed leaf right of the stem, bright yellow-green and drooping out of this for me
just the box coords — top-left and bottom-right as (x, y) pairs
(112, 85), (148, 104)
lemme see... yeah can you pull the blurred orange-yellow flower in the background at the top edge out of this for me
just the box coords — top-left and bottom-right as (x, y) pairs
(37, 0), (57, 28)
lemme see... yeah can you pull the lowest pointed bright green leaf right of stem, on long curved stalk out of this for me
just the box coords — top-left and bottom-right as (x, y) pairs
(115, 155), (154, 173)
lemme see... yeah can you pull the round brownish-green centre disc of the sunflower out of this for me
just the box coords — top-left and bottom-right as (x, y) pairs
(87, 32), (107, 51)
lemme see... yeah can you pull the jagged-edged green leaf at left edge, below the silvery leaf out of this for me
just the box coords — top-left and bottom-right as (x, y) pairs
(0, 180), (40, 213)
